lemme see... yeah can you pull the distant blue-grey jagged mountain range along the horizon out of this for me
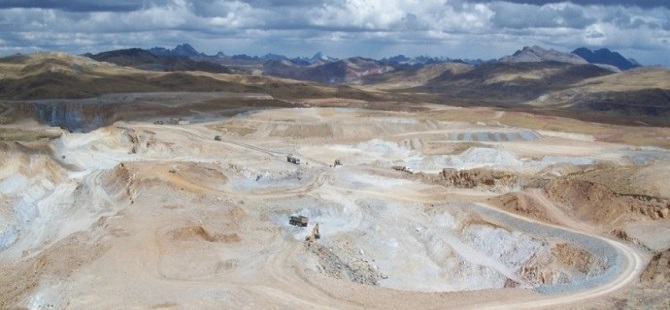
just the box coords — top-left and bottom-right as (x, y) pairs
(85, 43), (640, 85)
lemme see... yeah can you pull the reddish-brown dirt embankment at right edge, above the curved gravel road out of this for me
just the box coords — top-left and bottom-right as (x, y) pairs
(490, 166), (670, 237)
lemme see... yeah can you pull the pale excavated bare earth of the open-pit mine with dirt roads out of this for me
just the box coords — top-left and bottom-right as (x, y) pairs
(0, 101), (670, 309)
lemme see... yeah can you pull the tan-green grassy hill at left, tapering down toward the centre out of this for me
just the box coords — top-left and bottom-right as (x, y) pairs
(0, 53), (375, 101)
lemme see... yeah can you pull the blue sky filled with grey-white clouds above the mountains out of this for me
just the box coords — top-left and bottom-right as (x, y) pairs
(0, 0), (670, 65)
